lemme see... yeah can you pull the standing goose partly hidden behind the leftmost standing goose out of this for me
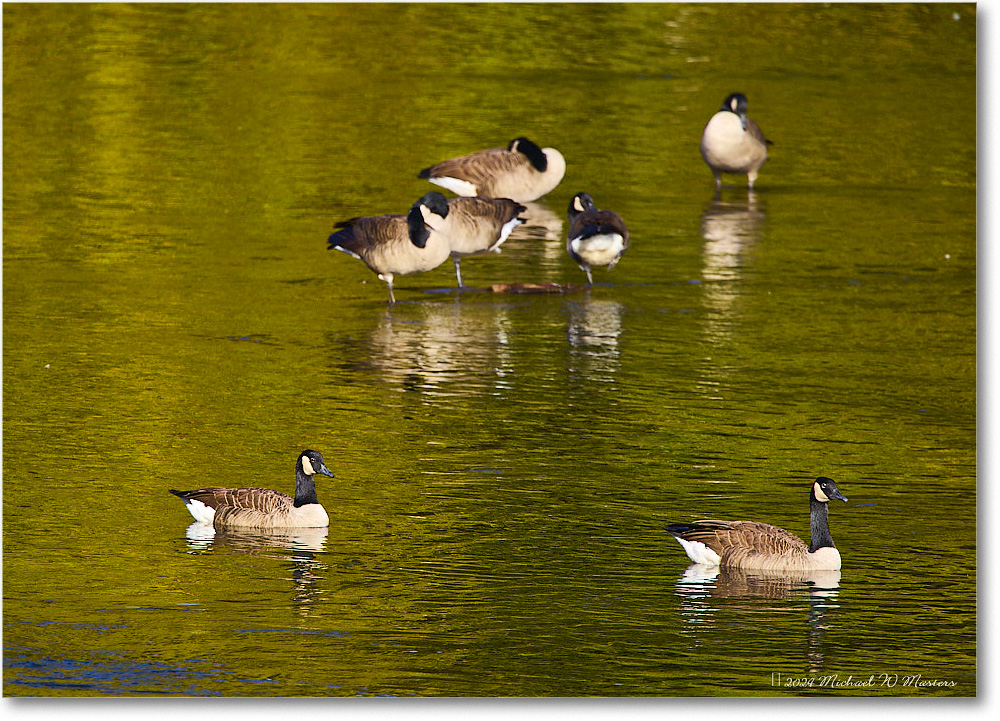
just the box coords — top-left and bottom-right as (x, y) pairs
(424, 192), (525, 288)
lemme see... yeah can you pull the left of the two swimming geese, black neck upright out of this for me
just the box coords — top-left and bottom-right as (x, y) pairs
(170, 451), (333, 528)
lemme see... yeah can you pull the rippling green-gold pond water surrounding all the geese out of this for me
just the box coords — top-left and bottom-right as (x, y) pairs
(3, 4), (977, 696)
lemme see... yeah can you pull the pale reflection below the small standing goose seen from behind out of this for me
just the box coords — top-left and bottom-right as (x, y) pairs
(566, 297), (624, 380)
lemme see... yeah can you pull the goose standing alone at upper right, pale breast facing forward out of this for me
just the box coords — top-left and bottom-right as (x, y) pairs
(701, 93), (772, 190)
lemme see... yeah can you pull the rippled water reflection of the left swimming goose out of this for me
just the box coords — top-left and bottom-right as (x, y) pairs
(185, 521), (330, 616)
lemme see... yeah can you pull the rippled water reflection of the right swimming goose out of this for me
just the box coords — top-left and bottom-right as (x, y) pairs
(675, 563), (841, 673)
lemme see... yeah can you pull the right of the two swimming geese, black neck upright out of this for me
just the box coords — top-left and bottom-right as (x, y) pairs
(667, 478), (847, 572)
